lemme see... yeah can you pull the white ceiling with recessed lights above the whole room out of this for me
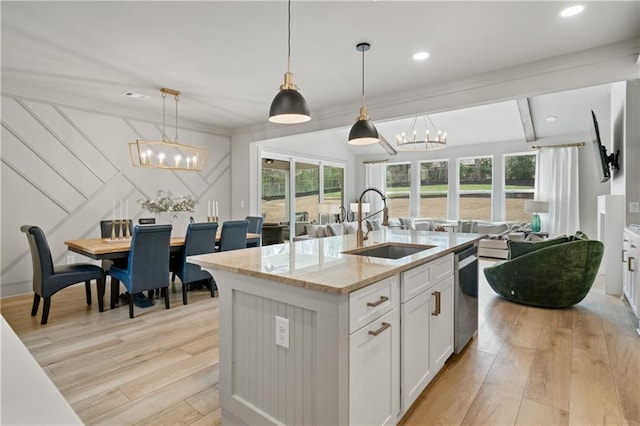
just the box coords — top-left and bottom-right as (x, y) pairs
(1, 0), (640, 151)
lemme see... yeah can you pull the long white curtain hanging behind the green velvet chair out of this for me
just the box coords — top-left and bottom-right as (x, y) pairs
(536, 147), (580, 236)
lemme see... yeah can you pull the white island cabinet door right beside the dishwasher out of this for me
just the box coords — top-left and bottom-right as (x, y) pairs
(428, 277), (454, 375)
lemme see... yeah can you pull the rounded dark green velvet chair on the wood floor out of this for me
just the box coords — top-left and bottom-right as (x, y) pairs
(484, 237), (604, 308)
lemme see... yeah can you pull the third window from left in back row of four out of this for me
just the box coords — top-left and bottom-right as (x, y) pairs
(458, 157), (493, 221)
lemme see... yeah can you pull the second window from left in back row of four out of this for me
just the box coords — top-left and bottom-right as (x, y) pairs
(420, 160), (449, 218)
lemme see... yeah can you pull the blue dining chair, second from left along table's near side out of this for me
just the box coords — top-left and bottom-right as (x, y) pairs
(170, 222), (218, 305)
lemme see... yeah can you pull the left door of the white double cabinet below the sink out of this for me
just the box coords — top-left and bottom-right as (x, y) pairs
(400, 291), (432, 412)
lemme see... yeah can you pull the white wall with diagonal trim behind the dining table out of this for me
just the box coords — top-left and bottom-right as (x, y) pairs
(0, 95), (231, 296)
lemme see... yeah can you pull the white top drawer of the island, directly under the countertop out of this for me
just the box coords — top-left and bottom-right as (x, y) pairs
(349, 275), (398, 333)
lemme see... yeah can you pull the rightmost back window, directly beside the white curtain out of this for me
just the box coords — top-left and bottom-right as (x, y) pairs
(504, 154), (536, 222)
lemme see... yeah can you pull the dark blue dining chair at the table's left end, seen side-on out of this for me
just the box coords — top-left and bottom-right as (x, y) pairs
(20, 225), (104, 324)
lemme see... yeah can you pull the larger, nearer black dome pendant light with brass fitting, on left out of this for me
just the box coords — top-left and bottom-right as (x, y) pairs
(269, 0), (311, 124)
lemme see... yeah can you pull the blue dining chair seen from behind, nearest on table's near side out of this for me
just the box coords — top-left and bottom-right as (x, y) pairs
(109, 225), (171, 318)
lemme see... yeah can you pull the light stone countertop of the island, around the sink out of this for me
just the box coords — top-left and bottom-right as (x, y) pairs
(189, 229), (486, 294)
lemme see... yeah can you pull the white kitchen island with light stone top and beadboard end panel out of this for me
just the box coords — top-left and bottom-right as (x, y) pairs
(190, 230), (484, 425)
